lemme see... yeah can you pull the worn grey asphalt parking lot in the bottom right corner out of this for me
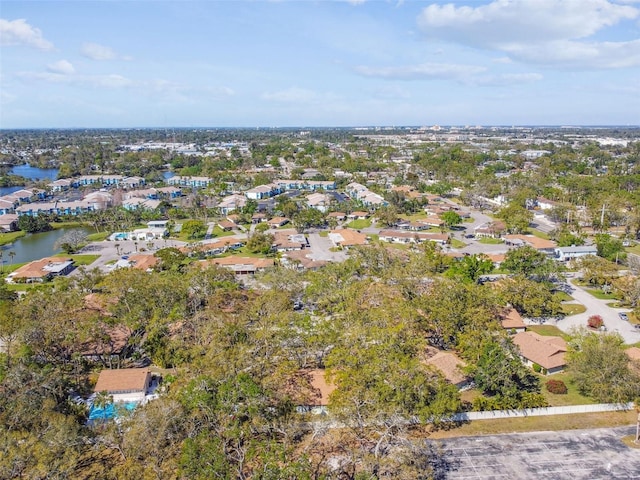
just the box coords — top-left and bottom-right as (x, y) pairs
(437, 427), (640, 480)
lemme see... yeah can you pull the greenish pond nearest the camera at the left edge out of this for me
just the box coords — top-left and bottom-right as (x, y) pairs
(0, 227), (92, 265)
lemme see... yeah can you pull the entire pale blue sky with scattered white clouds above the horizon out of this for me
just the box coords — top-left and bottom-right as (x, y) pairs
(0, 0), (640, 128)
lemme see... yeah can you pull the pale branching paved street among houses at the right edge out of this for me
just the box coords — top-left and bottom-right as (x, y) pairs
(557, 282), (640, 344)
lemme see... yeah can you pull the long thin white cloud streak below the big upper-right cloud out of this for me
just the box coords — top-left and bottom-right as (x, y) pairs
(355, 63), (486, 80)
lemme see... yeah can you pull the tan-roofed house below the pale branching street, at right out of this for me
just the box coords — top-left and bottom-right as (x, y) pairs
(513, 332), (567, 374)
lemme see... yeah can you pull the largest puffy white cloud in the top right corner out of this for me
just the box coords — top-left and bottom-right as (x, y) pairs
(418, 0), (640, 68)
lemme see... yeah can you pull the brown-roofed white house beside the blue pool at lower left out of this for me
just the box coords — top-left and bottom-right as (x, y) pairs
(93, 368), (152, 403)
